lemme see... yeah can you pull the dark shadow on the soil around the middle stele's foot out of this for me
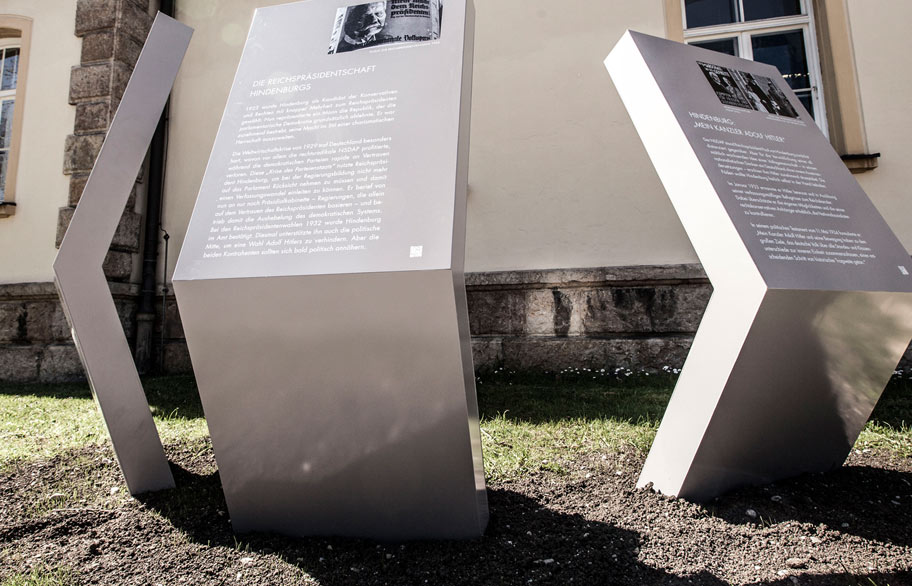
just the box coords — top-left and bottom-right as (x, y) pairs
(138, 464), (725, 586)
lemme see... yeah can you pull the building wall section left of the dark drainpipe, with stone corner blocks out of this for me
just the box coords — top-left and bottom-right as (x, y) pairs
(0, 0), (152, 382)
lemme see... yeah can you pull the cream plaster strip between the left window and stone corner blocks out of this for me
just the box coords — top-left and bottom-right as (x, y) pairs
(0, 0), (81, 284)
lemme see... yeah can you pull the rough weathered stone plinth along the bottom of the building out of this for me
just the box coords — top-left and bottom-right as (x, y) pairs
(7, 265), (912, 381)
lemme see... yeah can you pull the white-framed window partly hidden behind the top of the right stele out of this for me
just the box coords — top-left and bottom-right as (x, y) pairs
(681, 0), (827, 134)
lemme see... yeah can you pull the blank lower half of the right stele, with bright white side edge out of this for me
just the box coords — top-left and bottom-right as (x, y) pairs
(638, 288), (912, 501)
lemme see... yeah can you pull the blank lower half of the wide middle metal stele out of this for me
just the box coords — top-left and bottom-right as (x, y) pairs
(175, 270), (487, 539)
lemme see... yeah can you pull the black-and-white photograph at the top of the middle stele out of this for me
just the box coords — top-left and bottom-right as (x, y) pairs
(329, 0), (443, 55)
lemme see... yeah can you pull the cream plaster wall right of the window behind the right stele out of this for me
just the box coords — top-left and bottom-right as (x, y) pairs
(848, 0), (912, 251)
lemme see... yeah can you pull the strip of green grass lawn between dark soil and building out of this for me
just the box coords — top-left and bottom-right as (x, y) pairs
(0, 371), (912, 481)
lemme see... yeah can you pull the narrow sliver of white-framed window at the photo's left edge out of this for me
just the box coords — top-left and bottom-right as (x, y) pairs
(0, 15), (32, 218)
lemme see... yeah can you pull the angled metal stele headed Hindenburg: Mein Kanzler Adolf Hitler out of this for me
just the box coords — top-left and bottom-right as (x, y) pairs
(605, 31), (912, 500)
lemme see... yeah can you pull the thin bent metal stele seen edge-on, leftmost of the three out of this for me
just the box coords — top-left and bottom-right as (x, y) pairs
(54, 14), (193, 494)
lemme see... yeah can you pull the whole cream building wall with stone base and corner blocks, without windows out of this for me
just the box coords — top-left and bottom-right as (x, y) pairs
(0, 0), (912, 380)
